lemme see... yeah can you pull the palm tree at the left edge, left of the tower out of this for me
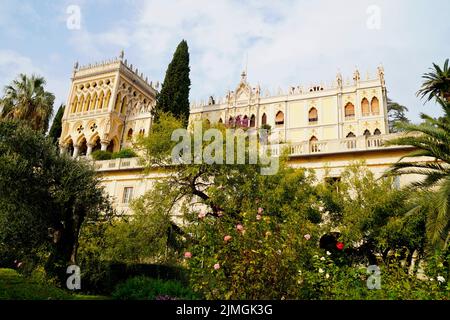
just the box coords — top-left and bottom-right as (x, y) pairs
(0, 74), (55, 132)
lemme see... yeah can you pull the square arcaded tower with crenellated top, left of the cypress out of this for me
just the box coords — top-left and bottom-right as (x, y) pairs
(59, 51), (157, 157)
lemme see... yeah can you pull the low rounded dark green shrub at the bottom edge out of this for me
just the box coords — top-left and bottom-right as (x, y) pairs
(112, 276), (197, 300)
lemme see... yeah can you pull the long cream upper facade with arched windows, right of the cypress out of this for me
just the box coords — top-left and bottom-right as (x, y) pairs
(191, 67), (389, 148)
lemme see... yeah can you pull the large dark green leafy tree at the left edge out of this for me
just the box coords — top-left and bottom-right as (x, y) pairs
(0, 121), (112, 279)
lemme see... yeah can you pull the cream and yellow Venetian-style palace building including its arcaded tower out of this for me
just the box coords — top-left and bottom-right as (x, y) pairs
(60, 52), (423, 212)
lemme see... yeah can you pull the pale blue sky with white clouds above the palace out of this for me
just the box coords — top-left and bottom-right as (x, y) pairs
(0, 0), (450, 121)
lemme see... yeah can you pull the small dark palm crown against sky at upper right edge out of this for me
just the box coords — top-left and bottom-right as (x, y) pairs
(417, 59), (450, 102)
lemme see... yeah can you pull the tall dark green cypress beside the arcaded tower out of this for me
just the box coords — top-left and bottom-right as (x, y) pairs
(154, 40), (191, 124)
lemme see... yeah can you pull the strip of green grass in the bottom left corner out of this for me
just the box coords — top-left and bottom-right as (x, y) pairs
(0, 269), (108, 300)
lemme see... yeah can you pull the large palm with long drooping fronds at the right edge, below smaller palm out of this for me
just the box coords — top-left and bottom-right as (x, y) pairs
(388, 98), (450, 246)
